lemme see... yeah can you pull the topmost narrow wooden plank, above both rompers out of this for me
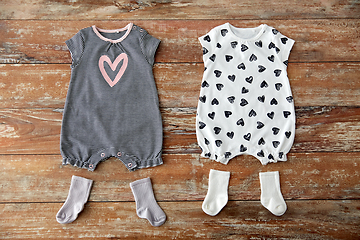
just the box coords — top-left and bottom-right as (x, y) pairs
(0, 0), (360, 20)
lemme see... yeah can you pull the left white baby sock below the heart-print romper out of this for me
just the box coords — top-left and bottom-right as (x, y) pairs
(202, 169), (230, 216)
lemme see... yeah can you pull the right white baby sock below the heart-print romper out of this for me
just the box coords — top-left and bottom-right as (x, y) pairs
(259, 171), (286, 216)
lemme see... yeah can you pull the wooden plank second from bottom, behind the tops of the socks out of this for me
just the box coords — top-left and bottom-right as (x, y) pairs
(0, 153), (360, 203)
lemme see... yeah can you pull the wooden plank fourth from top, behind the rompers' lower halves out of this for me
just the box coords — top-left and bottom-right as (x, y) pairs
(0, 107), (360, 154)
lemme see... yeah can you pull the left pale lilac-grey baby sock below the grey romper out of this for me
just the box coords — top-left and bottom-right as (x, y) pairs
(56, 176), (93, 224)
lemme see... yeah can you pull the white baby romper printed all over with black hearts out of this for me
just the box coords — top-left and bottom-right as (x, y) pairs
(196, 23), (295, 165)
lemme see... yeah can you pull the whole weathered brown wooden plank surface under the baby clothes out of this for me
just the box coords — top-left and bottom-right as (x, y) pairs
(0, 0), (360, 239)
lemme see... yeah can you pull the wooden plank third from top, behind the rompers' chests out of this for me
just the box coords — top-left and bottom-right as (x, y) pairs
(0, 62), (360, 108)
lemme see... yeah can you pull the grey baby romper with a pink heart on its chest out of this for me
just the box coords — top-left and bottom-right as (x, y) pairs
(60, 23), (163, 171)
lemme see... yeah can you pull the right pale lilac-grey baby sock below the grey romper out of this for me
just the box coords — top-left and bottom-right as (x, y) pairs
(130, 178), (166, 227)
